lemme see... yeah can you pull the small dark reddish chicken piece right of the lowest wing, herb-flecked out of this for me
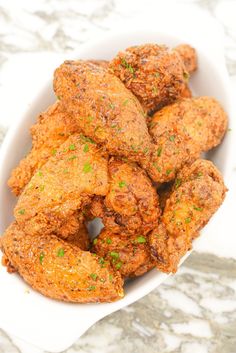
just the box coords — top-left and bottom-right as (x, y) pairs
(92, 229), (155, 277)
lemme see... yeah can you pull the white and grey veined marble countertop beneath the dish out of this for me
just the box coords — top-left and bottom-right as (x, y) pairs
(0, 0), (236, 353)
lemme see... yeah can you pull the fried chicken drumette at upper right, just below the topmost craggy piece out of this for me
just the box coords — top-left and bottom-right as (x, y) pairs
(144, 97), (227, 183)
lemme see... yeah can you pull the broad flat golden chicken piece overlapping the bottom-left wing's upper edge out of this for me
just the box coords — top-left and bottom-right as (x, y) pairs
(14, 135), (108, 237)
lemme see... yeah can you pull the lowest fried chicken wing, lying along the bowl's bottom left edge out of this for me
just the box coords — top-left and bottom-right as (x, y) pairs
(1, 223), (123, 303)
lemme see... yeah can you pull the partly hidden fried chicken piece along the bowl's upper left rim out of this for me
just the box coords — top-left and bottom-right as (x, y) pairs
(8, 101), (78, 196)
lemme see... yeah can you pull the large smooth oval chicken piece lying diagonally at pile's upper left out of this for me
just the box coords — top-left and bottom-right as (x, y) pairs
(54, 61), (151, 161)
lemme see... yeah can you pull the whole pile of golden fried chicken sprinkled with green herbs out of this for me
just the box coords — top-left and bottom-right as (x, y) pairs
(0, 44), (227, 303)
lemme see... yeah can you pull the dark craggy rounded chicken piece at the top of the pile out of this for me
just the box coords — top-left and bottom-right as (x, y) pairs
(109, 44), (188, 112)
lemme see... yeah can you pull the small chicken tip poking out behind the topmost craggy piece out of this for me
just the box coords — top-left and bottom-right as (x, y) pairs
(174, 44), (198, 73)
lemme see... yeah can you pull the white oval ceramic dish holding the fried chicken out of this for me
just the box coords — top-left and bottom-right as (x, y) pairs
(0, 31), (231, 352)
